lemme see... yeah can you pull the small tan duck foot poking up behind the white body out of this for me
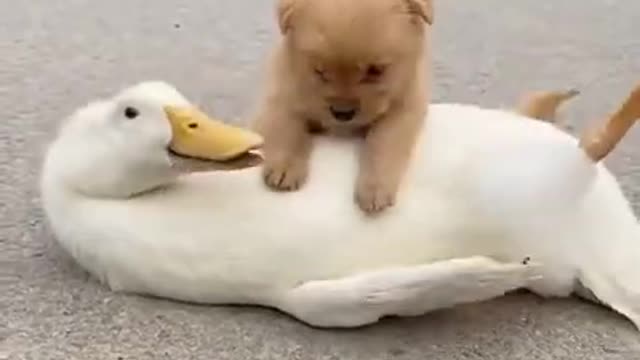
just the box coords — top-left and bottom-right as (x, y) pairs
(515, 89), (580, 124)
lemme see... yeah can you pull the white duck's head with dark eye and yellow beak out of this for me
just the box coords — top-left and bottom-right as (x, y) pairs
(43, 82), (262, 197)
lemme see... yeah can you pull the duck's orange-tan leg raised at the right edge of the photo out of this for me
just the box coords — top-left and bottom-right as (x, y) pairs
(580, 84), (640, 162)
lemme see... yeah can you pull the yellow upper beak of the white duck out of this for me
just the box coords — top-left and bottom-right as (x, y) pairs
(164, 106), (263, 161)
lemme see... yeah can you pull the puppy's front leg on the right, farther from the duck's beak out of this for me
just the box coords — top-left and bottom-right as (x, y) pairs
(355, 110), (424, 214)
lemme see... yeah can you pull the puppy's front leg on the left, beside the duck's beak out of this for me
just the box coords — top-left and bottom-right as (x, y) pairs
(254, 108), (312, 191)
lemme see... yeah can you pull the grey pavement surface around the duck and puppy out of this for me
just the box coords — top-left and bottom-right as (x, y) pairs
(0, 0), (640, 360)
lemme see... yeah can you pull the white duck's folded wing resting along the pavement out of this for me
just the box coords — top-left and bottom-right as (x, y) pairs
(278, 257), (540, 327)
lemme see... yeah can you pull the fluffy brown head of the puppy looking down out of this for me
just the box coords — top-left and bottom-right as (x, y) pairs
(278, 0), (433, 126)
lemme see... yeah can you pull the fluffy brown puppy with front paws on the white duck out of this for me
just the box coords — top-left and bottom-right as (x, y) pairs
(254, 0), (433, 213)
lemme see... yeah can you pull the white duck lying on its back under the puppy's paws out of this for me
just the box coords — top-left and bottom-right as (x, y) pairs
(41, 82), (640, 327)
